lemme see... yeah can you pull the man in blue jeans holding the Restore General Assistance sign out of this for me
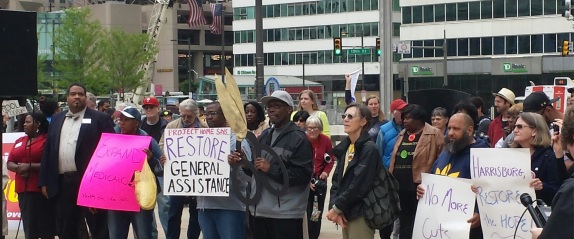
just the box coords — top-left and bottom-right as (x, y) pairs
(197, 102), (251, 239)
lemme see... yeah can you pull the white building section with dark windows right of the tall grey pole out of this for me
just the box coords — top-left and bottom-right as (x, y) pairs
(399, 0), (574, 101)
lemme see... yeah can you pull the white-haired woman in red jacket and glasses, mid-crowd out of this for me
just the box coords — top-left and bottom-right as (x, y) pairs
(305, 116), (335, 239)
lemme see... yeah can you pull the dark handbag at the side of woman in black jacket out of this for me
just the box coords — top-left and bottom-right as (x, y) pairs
(362, 164), (401, 230)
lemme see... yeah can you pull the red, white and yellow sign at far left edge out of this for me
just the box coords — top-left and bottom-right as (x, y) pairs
(2, 133), (25, 230)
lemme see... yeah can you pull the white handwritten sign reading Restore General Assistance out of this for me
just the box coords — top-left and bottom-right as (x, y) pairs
(164, 128), (231, 196)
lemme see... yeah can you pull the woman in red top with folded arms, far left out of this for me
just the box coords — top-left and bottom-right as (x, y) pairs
(8, 112), (57, 239)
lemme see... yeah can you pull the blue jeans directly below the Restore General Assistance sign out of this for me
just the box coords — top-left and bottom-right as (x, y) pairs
(198, 209), (245, 239)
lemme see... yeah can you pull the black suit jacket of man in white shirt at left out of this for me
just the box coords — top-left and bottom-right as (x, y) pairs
(38, 108), (114, 198)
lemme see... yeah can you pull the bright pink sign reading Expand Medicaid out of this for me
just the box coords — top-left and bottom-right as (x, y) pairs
(78, 133), (151, 212)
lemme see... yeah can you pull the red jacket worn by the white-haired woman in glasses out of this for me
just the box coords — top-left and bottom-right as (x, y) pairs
(309, 134), (335, 177)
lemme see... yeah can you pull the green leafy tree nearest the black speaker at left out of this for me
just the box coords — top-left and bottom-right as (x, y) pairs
(54, 8), (105, 94)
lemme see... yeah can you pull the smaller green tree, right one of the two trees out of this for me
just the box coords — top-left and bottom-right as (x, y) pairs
(99, 28), (157, 96)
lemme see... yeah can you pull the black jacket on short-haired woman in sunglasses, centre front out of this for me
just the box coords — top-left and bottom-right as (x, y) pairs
(329, 133), (382, 220)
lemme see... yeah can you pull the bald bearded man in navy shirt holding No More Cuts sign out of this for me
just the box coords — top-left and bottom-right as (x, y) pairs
(424, 113), (489, 239)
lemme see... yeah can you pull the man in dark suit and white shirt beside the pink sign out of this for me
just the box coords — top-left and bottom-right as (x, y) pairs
(38, 83), (114, 239)
